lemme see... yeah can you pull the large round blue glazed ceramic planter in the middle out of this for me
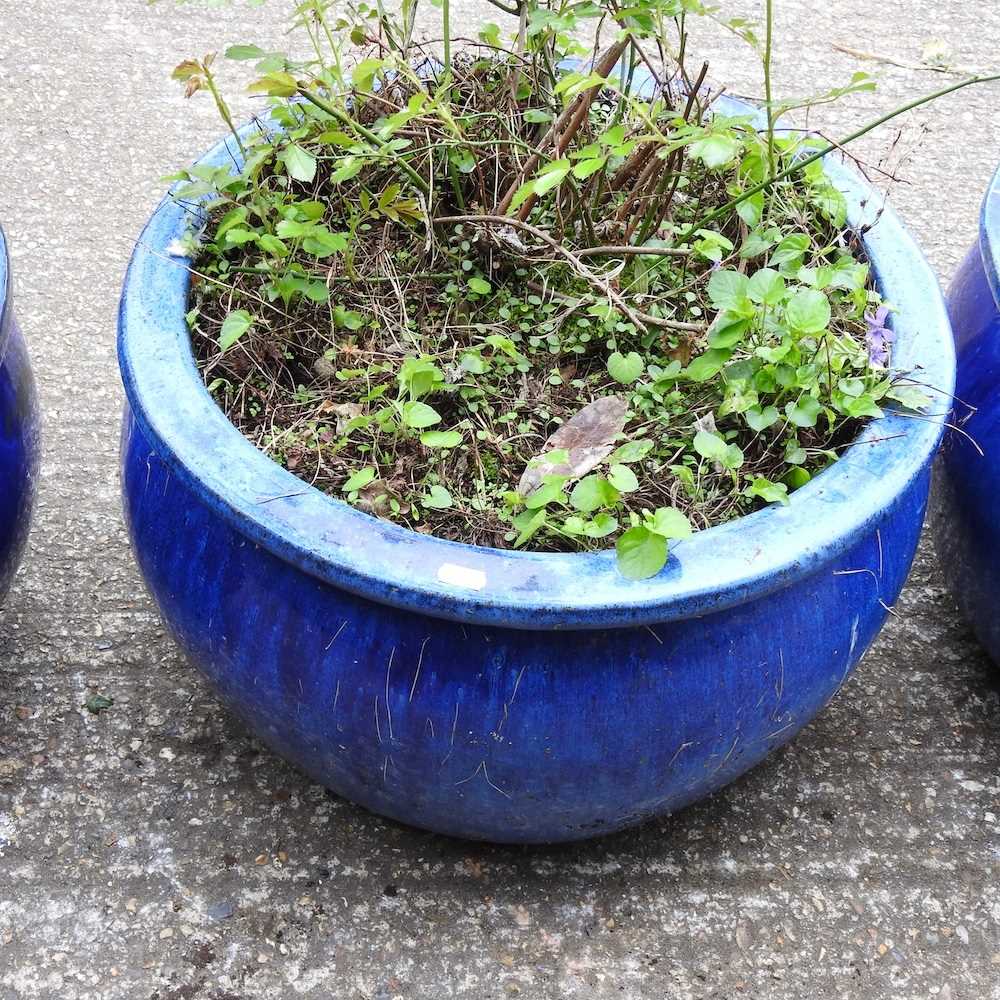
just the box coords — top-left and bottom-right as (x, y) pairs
(119, 113), (953, 842)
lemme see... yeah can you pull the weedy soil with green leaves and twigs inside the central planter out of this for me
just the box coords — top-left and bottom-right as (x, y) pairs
(181, 58), (919, 551)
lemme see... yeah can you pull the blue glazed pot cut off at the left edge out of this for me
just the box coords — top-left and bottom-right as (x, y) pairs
(0, 230), (38, 603)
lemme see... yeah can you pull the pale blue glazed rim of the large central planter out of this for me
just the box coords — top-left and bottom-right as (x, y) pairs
(118, 109), (952, 629)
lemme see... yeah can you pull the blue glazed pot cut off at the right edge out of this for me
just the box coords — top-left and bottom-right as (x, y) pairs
(933, 170), (1000, 662)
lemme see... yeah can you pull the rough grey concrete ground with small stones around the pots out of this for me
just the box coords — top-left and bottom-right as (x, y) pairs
(0, 0), (1000, 1000)
